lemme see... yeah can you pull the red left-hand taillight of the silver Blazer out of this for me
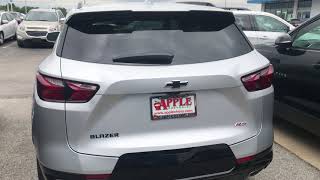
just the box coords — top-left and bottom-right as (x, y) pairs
(37, 74), (99, 103)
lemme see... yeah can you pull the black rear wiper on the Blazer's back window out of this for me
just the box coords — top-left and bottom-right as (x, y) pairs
(113, 54), (174, 64)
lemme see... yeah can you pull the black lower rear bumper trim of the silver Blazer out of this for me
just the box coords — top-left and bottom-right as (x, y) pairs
(40, 144), (273, 180)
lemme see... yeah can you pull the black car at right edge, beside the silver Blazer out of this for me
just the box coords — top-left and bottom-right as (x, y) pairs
(256, 15), (320, 136)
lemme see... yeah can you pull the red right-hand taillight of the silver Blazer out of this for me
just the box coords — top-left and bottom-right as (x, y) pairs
(241, 65), (274, 92)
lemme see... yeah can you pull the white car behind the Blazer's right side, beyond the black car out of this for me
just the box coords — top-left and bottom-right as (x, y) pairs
(232, 11), (295, 45)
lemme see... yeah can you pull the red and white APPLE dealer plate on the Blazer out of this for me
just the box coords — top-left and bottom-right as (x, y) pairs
(151, 94), (197, 120)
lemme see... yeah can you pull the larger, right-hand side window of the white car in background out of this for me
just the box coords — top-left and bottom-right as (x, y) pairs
(253, 15), (289, 32)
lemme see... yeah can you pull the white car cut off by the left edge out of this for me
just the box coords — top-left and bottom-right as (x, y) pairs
(0, 11), (18, 45)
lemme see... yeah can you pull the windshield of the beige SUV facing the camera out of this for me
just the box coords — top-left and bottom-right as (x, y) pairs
(25, 11), (58, 22)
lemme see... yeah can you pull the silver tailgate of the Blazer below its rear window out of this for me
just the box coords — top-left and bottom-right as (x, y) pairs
(56, 51), (268, 156)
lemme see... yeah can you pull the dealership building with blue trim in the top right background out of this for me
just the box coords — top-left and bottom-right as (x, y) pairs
(248, 0), (320, 21)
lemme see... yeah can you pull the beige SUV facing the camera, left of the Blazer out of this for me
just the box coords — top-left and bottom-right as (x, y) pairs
(17, 9), (65, 47)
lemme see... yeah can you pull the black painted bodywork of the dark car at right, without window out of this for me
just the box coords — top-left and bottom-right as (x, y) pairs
(256, 16), (320, 135)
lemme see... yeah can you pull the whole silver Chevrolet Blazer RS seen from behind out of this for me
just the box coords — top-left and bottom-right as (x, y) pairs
(32, 2), (273, 180)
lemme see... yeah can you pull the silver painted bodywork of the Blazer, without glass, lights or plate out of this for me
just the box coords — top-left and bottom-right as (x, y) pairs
(32, 3), (273, 179)
